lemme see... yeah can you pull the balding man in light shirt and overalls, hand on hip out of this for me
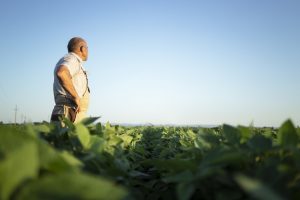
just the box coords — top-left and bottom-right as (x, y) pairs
(51, 37), (90, 123)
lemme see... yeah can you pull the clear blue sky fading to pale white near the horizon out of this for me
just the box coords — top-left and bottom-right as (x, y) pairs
(0, 0), (300, 126)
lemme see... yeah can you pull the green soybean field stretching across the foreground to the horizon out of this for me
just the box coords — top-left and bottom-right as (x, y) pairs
(0, 118), (300, 200)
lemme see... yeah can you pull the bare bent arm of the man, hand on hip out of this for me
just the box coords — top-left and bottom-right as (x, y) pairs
(56, 65), (80, 112)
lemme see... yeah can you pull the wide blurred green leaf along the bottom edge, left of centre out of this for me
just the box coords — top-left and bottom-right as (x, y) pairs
(16, 173), (127, 200)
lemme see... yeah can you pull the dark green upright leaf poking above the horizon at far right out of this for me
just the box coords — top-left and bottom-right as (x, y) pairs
(278, 120), (299, 147)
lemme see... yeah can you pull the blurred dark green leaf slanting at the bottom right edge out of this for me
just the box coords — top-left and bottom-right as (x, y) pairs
(235, 174), (283, 200)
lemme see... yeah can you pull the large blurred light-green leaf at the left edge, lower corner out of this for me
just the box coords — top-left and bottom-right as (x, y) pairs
(0, 132), (39, 200)
